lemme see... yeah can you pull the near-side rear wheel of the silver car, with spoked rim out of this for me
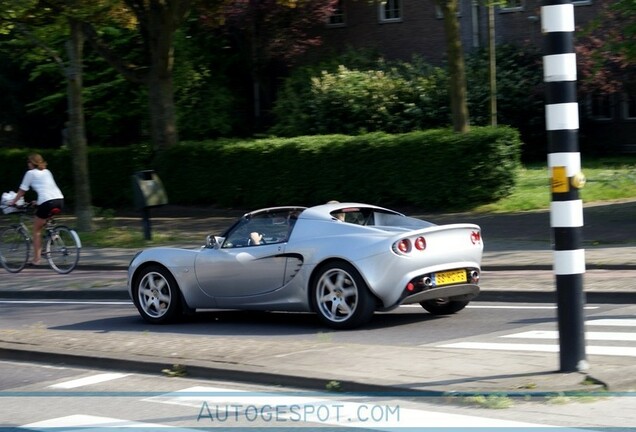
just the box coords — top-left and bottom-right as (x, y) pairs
(312, 262), (375, 329)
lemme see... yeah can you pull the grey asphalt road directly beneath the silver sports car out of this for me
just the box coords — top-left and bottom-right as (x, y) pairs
(0, 300), (636, 347)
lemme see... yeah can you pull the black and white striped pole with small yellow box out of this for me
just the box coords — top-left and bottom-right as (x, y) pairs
(541, 0), (588, 372)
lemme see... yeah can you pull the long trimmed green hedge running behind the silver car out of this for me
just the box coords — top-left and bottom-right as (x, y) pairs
(0, 127), (521, 211)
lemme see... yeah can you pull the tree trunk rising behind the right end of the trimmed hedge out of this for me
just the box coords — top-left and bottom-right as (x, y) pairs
(436, 0), (470, 133)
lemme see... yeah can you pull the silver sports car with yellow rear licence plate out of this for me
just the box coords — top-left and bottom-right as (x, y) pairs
(128, 203), (483, 329)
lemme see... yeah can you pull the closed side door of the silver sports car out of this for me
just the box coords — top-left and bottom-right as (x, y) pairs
(195, 243), (287, 300)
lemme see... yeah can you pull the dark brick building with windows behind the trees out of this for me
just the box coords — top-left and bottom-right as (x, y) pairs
(316, 0), (636, 152)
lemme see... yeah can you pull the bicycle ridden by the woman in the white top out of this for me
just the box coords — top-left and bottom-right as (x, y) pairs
(0, 205), (82, 274)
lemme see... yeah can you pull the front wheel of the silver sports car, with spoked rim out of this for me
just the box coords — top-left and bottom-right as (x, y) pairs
(132, 265), (181, 324)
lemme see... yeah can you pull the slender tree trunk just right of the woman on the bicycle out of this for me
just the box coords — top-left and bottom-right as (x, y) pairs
(66, 18), (93, 232)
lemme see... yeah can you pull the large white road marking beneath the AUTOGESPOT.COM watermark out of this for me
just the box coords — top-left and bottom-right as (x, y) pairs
(145, 387), (554, 431)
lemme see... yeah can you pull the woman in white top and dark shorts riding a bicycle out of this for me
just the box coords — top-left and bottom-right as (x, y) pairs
(9, 153), (64, 265)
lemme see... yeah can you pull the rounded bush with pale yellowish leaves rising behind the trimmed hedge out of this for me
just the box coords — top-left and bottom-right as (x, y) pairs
(270, 52), (449, 136)
